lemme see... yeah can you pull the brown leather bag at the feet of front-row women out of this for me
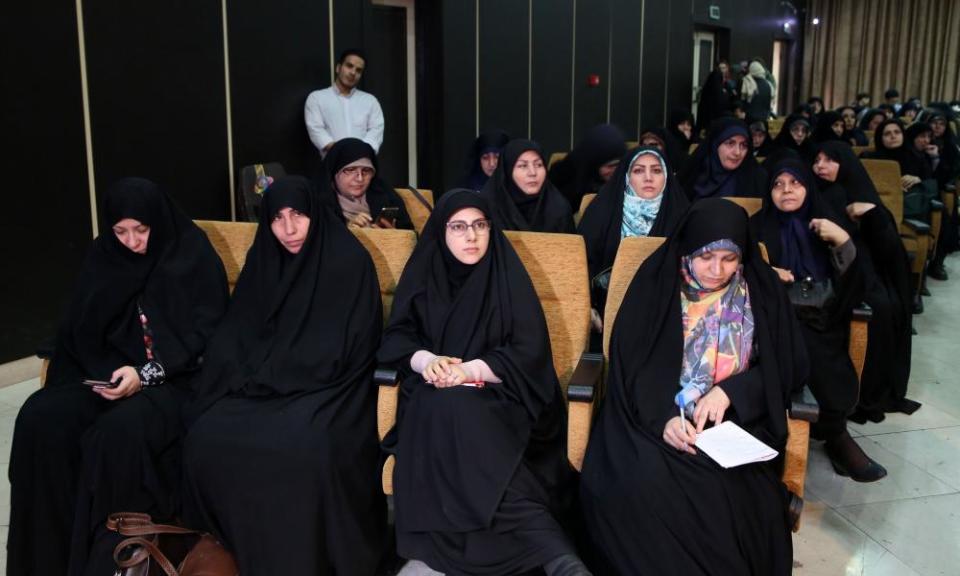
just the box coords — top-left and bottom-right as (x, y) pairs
(107, 512), (240, 576)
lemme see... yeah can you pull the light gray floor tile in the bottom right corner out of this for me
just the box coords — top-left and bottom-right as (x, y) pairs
(837, 494), (960, 576)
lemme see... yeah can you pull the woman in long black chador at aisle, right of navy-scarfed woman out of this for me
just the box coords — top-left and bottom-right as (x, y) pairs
(813, 142), (920, 424)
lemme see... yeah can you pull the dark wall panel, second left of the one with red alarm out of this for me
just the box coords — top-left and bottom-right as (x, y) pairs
(479, 0), (530, 138)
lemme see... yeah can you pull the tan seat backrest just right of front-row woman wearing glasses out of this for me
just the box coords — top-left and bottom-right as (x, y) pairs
(504, 231), (590, 391)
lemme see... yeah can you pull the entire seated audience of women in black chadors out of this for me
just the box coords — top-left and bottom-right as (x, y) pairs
(7, 86), (960, 576)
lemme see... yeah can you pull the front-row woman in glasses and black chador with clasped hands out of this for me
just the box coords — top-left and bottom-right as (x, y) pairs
(378, 189), (587, 575)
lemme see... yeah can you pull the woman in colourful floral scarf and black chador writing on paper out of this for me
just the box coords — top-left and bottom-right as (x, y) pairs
(581, 198), (807, 576)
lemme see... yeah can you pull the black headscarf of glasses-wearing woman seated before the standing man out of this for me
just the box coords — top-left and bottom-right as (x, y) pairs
(318, 138), (413, 230)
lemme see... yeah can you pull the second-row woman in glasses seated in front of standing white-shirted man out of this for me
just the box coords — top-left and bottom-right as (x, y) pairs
(321, 138), (413, 230)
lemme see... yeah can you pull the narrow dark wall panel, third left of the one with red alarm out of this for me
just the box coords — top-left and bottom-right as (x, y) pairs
(440, 0), (477, 186)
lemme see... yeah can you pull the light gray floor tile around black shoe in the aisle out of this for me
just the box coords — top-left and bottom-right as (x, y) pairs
(806, 438), (956, 508)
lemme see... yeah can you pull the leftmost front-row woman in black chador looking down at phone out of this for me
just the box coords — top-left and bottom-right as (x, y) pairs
(7, 178), (228, 576)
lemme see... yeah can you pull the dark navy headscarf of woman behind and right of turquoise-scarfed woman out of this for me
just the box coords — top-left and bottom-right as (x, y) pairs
(680, 118), (766, 201)
